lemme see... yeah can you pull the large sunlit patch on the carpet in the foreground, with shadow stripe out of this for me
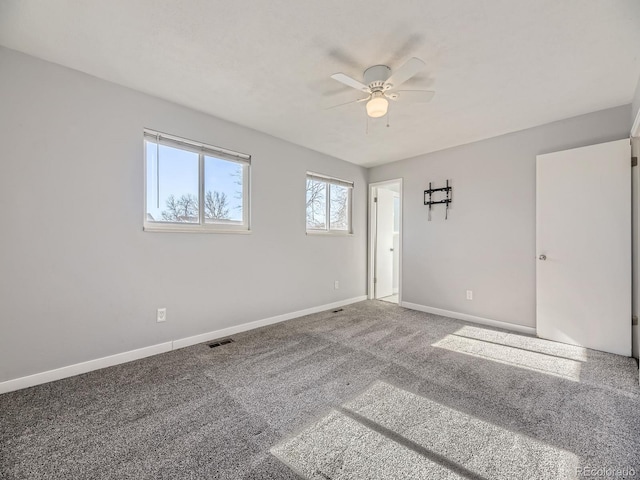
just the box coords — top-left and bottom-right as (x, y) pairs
(271, 382), (578, 480)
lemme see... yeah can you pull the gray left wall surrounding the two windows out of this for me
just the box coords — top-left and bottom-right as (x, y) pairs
(0, 49), (367, 381)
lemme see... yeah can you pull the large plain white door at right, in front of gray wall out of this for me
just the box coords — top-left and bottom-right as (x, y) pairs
(536, 139), (631, 356)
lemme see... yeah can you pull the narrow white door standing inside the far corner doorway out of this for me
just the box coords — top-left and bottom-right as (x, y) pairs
(375, 188), (393, 298)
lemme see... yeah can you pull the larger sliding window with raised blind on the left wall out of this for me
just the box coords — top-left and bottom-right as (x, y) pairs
(144, 130), (251, 232)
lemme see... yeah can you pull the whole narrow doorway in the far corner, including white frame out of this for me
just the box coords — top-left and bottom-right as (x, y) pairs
(369, 179), (402, 304)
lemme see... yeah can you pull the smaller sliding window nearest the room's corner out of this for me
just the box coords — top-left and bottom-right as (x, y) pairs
(307, 173), (353, 234)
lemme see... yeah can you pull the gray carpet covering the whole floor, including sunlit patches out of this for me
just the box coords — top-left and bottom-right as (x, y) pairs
(0, 301), (640, 480)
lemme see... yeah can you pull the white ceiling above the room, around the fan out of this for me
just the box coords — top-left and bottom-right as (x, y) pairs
(0, 0), (640, 166)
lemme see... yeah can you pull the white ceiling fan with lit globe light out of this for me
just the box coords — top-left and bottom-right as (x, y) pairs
(330, 57), (435, 118)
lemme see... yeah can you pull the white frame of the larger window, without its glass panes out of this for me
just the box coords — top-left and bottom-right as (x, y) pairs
(142, 128), (251, 234)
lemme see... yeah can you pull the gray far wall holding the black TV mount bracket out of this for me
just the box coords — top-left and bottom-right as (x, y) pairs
(369, 105), (631, 327)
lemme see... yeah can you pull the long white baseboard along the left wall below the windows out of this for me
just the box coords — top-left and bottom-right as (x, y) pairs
(0, 295), (367, 394)
